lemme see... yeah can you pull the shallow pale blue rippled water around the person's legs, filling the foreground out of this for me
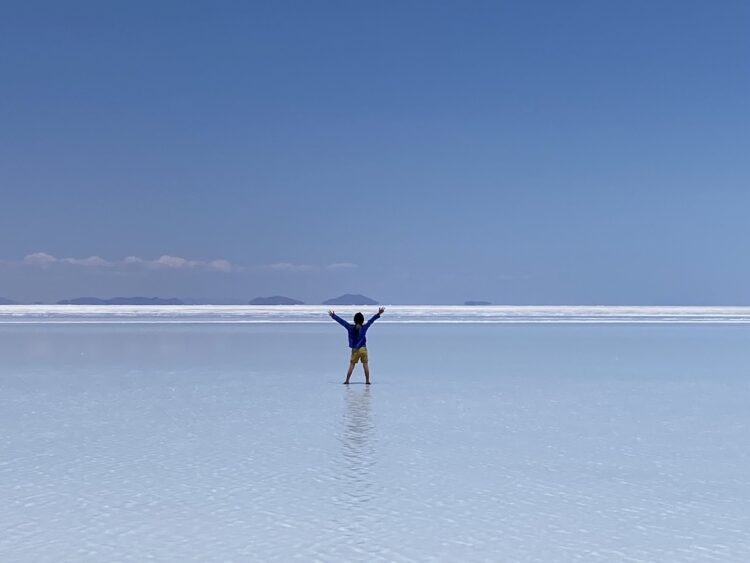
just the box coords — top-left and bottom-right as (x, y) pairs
(0, 313), (750, 562)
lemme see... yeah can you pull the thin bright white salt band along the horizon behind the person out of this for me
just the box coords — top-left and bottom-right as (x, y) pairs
(0, 305), (750, 324)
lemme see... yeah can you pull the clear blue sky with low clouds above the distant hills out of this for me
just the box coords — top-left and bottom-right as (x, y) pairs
(0, 0), (750, 304)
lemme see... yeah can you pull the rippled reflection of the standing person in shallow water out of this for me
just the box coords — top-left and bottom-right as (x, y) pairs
(339, 386), (375, 532)
